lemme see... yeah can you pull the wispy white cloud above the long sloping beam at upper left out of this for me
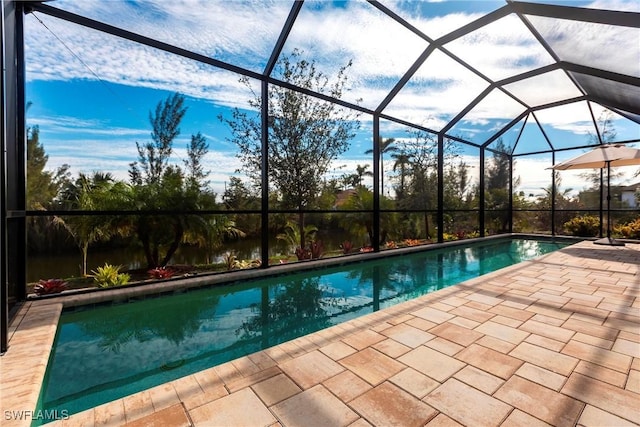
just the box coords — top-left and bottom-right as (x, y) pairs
(46, 0), (290, 71)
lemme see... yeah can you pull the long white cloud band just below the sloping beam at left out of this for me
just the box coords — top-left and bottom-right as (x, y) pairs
(25, 10), (259, 107)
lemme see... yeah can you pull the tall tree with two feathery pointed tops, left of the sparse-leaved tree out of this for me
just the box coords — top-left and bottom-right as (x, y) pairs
(129, 93), (215, 268)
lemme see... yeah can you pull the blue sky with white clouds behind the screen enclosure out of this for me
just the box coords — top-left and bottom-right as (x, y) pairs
(25, 0), (640, 201)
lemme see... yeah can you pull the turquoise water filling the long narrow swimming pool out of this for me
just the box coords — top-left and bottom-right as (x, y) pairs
(40, 239), (568, 420)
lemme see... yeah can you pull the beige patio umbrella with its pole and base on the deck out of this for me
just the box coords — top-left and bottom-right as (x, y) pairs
(552, 144), (640, 246)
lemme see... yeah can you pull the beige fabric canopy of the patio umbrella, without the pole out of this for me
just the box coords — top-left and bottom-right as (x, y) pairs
(552, 144), (640, 170)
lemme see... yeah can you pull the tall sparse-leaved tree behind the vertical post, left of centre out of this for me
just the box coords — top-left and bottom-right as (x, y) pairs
(220, 50), (359, 248)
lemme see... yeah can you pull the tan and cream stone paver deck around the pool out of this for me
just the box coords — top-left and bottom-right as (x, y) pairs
(0, 242), (640, 427)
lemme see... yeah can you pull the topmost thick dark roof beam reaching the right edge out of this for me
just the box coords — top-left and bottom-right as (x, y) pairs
(509, 1), (640, 28)
